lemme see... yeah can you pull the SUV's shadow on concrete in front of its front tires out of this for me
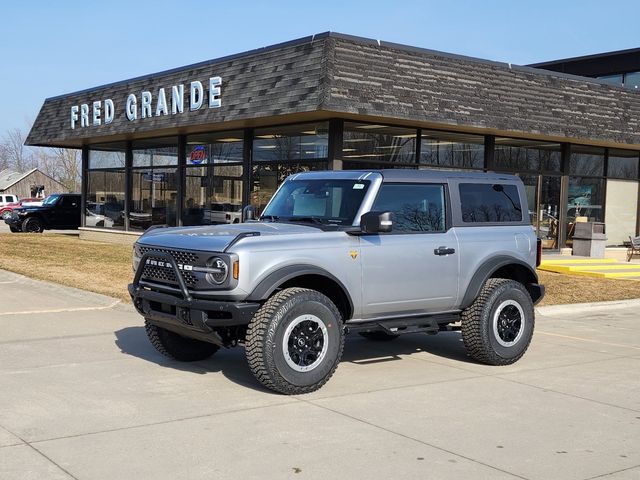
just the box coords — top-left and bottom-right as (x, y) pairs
(114, 327), (268, 393)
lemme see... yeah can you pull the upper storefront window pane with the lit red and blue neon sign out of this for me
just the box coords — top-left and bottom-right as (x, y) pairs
(185, 130), (244, 166)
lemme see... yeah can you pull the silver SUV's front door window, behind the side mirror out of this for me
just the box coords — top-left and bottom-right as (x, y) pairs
(373, 184), (445, 232)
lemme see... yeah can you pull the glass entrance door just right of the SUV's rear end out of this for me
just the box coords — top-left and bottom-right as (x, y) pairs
(520, 174), (561, 250)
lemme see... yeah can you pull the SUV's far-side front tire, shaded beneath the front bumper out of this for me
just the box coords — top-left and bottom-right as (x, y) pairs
(144, 320), (220, 362)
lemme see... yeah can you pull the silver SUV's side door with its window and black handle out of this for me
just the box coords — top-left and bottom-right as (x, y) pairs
(360, 184), (459, 318)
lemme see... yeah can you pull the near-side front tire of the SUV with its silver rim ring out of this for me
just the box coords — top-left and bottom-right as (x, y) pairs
(245, 288), (344, 395)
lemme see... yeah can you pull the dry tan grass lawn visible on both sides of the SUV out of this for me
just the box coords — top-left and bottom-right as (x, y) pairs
(0, 233), (640, 305)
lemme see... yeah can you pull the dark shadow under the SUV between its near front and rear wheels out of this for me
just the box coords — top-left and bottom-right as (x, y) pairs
(342, 332), (475, 365)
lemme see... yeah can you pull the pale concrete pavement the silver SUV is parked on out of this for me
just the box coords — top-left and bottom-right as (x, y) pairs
(0, 271), (640, 480)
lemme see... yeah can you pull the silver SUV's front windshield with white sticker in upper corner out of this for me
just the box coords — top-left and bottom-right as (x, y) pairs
(260, 179), (370, 225)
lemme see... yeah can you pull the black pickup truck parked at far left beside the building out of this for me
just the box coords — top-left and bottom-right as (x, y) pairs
(4, 193), (81, 233)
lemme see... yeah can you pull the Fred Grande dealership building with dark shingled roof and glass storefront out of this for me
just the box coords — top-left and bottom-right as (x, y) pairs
(26, 33), (640, 250)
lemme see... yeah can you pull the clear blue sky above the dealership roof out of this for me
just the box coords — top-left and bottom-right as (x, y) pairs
(0, 0), (640, 136)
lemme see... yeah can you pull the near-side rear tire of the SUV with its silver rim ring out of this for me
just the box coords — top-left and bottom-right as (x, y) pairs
(462, 278), (535, 365)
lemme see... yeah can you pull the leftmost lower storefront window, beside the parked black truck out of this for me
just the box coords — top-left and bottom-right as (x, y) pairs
(84, 169), (125, 230)
